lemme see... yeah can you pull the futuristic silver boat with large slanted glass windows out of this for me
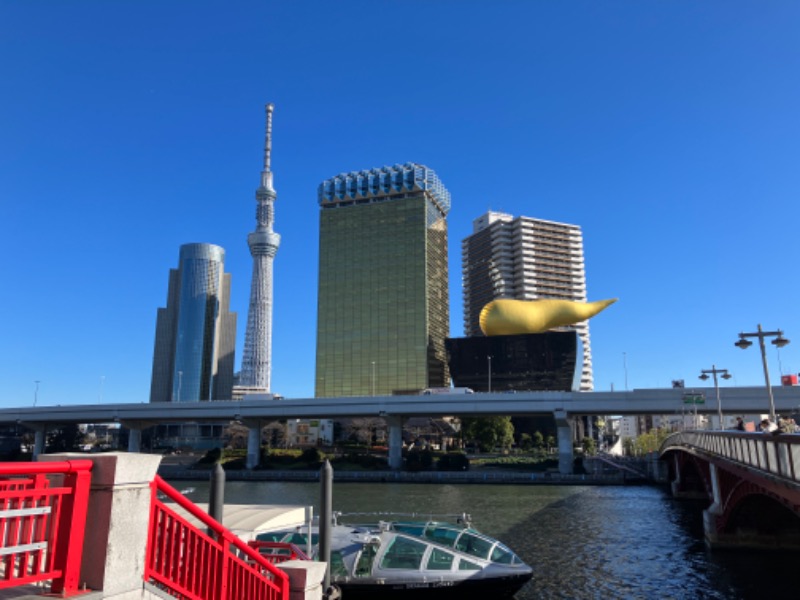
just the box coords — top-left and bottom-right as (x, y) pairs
(257, 514), (533, 600)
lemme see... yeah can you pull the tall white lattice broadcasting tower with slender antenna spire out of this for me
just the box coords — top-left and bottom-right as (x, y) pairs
(239, 104), (281, 392)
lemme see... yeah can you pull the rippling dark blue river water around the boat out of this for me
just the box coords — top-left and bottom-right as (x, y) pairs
(167, 481), (800, 600)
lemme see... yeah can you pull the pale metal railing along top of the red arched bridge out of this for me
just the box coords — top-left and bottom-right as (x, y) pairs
(661, 431), (800, 482)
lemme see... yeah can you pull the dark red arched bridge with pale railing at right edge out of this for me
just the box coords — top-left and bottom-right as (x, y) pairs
(660, 431), (800, 551)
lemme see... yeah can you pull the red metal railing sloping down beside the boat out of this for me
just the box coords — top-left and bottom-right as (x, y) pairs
(144, 476), (289, 600)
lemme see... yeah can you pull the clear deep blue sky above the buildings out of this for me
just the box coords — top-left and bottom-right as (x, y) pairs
(0, 0), (800, 407)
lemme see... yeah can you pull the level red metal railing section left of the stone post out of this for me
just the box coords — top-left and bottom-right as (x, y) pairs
(0, 460), (92, 598)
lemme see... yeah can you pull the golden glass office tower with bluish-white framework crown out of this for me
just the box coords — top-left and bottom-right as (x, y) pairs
(316, 163), (450, 397)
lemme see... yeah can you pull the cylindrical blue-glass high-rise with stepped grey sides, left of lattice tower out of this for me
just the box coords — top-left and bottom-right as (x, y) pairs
(150, 244), (236, 402)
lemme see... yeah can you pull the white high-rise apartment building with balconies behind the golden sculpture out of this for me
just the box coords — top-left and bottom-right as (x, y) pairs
(461, 211), (594, 391)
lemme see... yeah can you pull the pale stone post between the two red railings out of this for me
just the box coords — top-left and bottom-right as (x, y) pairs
(39, 452), (161, 600)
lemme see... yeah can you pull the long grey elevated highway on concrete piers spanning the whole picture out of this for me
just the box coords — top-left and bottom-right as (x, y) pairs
(0, 386), (800, 473)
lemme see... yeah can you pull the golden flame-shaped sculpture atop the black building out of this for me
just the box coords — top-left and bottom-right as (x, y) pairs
(480, 298), (617, 335)
